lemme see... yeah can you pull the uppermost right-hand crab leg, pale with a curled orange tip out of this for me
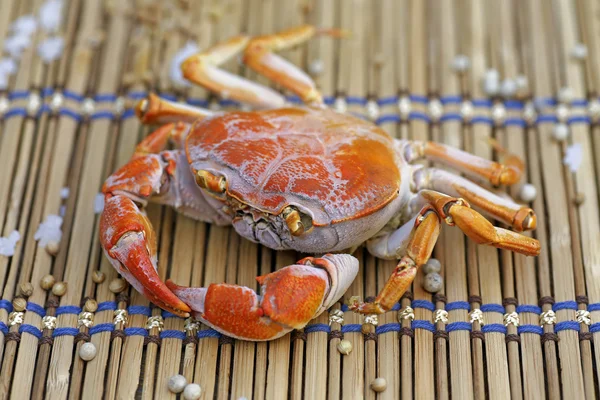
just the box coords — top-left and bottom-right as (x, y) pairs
(405, 141), (525, 186)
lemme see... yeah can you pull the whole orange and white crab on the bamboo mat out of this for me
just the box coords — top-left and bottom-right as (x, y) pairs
(100, 26), (540, 341)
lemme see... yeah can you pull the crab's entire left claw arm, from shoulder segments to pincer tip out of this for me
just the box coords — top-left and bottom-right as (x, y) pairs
(100, 124), (218, 316)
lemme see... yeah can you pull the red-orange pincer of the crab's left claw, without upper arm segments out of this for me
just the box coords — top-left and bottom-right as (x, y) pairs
(100, 195), (190, 317)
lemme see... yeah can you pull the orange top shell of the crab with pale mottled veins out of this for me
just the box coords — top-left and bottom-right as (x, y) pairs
(186, 108), (400, 226)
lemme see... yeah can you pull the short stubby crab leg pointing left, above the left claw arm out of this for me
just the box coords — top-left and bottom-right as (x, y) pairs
(135, 93), (214, 125)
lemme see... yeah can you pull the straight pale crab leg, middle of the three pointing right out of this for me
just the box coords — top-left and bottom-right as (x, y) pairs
(413, 168), (537, 232)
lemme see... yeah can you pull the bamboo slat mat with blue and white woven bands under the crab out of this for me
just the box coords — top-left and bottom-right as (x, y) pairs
(0, 0), (600, 400)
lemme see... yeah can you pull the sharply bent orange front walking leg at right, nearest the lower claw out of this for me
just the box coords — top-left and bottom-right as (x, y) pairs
(350, 190), (540, 314)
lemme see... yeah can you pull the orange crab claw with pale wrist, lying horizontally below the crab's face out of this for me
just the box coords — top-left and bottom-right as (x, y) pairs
(167, 254), (358, 341)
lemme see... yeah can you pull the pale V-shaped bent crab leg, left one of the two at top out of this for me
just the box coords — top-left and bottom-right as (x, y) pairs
(181, 36), (285, 108)
